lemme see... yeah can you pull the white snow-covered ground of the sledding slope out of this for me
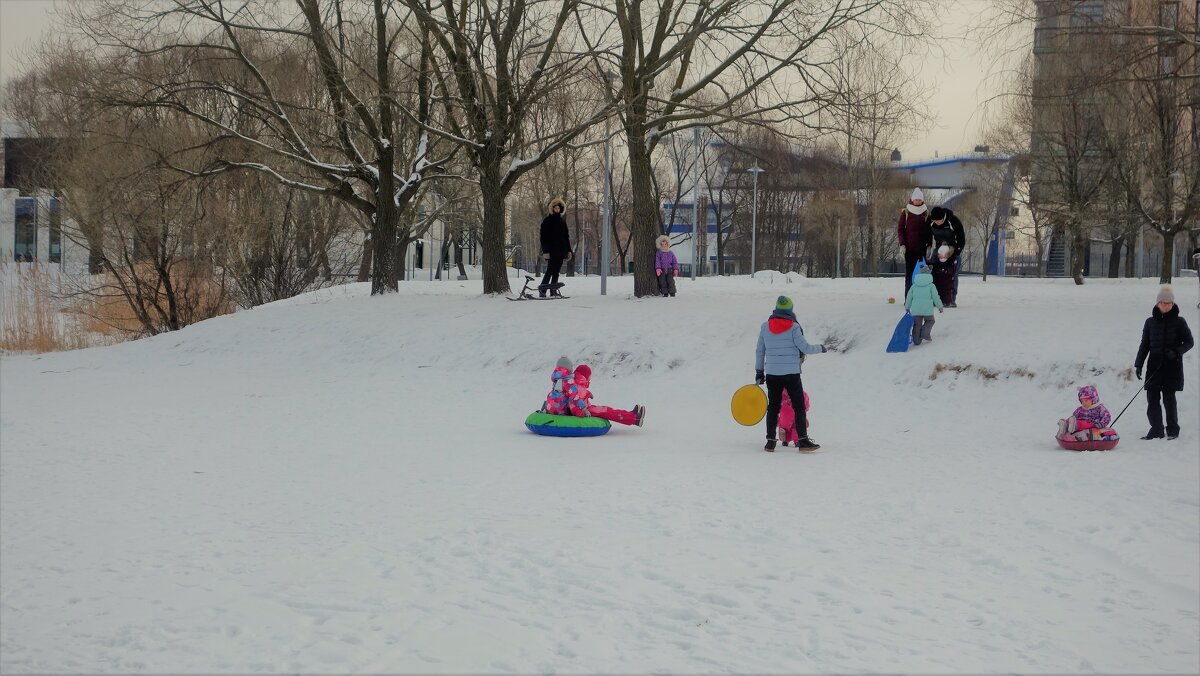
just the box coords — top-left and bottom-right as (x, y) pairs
(0, 273), (1200, 674)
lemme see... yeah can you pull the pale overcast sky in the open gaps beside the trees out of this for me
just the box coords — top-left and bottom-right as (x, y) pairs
(0, 0), (1012, 158)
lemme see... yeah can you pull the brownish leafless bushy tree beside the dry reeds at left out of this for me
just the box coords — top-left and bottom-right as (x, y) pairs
(54, 125), (233, 335)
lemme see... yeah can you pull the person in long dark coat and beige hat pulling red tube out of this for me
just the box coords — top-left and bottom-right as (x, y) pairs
(1133, 285), (1194, 439)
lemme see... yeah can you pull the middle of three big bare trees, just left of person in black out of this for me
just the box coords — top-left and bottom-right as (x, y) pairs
(404, 0), (612, 293)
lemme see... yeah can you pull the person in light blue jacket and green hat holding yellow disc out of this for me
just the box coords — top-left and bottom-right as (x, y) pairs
(754, 295), (826, 453)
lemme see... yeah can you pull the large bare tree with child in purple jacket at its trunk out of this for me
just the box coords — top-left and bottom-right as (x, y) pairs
(580, 0), (922, 297)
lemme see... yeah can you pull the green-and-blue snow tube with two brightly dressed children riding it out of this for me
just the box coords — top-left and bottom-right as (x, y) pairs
(526, 357), (646, 437)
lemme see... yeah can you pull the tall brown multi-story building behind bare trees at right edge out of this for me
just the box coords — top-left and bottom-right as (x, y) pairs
(1030, 0), (1200, 275)
